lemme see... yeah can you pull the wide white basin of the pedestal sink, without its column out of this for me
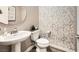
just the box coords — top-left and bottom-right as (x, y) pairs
(0, 31), (31, 45)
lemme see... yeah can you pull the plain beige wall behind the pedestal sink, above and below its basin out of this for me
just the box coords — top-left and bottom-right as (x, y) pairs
(0, 6), (39, 51)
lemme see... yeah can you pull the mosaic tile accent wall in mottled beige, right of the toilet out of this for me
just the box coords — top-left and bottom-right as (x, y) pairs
(39, 6), (76, 50)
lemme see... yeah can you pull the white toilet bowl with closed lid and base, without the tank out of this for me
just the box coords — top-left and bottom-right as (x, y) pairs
(36, 38), (49, 52)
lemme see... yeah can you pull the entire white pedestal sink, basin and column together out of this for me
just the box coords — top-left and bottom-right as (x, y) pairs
(0, 31), (31, 52)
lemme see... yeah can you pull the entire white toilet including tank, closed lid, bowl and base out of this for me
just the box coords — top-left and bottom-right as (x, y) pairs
(31, 30), (49, 52)
